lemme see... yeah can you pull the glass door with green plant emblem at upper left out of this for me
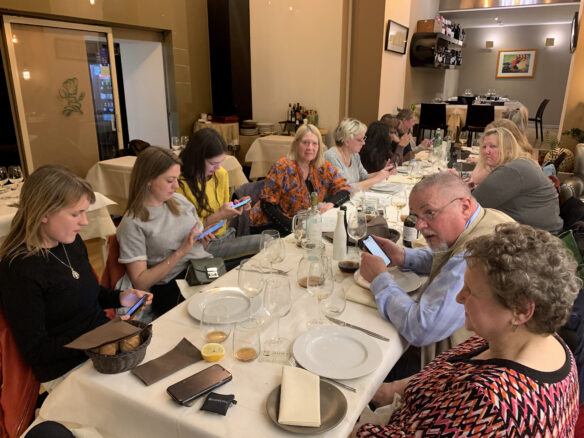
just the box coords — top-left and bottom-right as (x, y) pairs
(3, 16), (122, 177)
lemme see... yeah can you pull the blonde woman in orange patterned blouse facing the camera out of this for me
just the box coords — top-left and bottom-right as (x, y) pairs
(250, 125), (351, 235)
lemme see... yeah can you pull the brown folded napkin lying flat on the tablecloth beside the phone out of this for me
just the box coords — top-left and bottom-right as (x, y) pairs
(132, 338), (203, 386)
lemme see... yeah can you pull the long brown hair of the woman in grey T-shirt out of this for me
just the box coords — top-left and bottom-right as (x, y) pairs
(126, 146), (181, 222)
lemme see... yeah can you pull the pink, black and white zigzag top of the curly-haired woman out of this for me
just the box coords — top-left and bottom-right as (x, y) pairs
(357, 336), (578, 438)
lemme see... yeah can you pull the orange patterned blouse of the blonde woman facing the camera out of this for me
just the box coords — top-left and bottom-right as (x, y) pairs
(249, 157), (351, 227)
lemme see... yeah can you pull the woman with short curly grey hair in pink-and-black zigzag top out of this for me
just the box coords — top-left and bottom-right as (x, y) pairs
(357, 223), (581, 438)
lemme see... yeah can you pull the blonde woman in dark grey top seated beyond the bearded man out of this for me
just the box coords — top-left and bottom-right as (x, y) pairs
(473, 128), (563, 233)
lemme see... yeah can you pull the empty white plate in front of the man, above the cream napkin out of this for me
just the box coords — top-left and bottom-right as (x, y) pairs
(292, 326), (381, 379)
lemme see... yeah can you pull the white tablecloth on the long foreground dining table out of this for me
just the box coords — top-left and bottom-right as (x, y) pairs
(34, 236), (407, 438)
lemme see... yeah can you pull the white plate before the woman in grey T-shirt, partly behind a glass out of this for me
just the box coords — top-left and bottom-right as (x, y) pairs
(187, 287), (261, 324)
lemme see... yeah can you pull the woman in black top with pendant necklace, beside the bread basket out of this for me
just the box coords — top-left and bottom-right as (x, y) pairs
(0, 166), (152, 384)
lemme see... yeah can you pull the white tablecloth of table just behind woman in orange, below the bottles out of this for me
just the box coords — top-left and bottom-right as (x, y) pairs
(245, 135), (294, 180)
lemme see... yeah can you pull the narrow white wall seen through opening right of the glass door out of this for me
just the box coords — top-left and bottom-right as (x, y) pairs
(115, 39), (169, 146)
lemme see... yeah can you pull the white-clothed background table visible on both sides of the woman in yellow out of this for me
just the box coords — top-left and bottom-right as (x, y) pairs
(85, 155), (248, 215)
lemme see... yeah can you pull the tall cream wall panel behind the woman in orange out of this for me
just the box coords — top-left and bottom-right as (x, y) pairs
(249, 0), (342, 135)
